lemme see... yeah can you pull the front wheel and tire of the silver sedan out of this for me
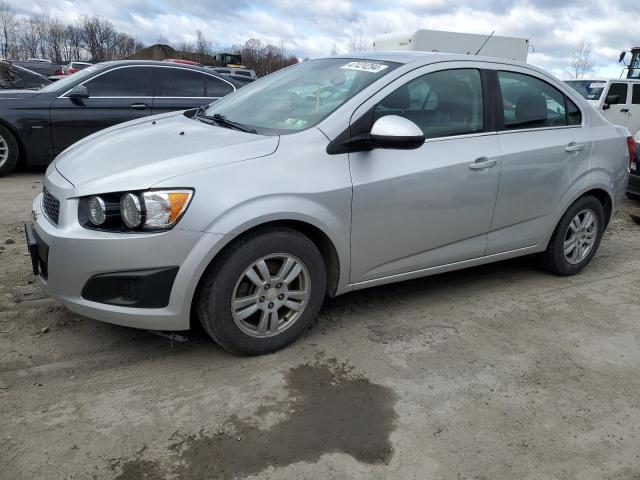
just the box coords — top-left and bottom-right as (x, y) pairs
(196, 228), (326, 355)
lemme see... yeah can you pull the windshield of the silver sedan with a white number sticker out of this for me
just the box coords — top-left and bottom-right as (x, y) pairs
(206, 58), (398, 135)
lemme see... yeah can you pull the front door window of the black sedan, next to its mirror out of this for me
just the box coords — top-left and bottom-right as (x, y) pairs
(85, 67), (152, 97)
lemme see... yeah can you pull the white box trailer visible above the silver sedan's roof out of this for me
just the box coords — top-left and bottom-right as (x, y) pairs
(373, 30), (529, 62)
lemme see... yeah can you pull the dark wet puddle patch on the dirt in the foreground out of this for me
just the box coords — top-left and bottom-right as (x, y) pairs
(112, 360), (397, 480)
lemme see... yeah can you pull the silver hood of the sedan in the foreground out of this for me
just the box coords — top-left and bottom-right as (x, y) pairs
(54, 112), (279, 196)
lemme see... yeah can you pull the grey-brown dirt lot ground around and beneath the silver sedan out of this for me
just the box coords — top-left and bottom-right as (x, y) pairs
(0, 173), (640, 480)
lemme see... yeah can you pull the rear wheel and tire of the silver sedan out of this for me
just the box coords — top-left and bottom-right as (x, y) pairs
(540, 195), (605, 275)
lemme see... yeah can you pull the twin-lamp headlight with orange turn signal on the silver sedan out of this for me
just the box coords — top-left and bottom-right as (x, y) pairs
(78, 189), (193, 232)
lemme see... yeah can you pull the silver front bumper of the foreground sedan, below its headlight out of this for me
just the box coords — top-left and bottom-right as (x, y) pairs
(27, 174), (230, 330)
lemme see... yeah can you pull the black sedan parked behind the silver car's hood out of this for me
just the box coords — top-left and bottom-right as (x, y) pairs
(0, 60), (242, 175)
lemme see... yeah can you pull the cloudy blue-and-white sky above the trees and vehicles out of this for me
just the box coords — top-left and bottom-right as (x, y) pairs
(7, 0), (640, 77)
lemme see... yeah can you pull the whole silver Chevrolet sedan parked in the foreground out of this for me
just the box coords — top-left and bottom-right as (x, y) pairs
(26, 52), (630, 354)
